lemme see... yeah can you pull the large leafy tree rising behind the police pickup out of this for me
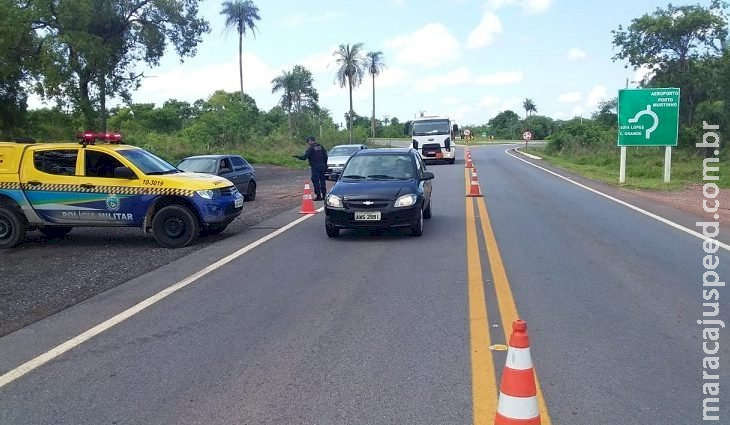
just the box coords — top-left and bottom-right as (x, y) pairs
(28, 0), (209, 130)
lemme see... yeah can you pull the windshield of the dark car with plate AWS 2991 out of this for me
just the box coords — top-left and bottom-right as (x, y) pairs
(342, 154), (415, 180)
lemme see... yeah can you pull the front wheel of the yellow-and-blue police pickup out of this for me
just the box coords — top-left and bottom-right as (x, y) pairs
(152, 205), (200, 248)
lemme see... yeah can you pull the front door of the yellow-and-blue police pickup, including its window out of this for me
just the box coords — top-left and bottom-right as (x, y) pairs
(79, 146), (141, 226)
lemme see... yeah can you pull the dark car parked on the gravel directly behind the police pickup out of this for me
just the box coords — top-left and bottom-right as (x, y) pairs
(177, 155), (256, 202)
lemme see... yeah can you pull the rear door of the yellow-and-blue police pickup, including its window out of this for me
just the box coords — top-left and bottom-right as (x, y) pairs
(21, 146), (79, 225)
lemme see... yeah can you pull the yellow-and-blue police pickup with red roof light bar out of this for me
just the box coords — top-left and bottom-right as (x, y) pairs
(0, 132), (243, 248)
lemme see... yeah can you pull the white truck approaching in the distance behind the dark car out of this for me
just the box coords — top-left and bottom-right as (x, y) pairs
(403, 116), (459, 164)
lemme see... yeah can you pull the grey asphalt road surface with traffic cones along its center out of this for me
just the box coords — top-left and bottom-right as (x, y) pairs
(0, 147), (730, 425)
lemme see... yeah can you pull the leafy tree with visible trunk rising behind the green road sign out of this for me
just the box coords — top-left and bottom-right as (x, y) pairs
(612, 0), (728, 123)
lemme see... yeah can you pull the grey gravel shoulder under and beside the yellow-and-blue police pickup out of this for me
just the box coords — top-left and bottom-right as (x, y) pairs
(0, 165), (316, 336)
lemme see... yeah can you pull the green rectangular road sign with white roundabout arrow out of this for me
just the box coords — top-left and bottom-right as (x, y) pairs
(618, 88), (679, 146)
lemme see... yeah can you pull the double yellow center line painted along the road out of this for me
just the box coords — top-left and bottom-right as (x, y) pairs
(464, 169), (551, 425)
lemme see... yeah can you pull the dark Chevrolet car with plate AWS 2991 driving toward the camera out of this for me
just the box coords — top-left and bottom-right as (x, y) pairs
(325, 149), (434, 237)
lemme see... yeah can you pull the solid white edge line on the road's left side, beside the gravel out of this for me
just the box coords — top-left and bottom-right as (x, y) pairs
(0, 207), (324, 388)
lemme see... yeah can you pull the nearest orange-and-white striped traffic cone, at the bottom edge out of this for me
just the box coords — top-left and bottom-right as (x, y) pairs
(494, 320), (541, 425)
